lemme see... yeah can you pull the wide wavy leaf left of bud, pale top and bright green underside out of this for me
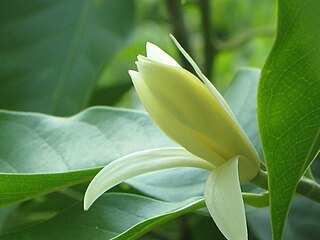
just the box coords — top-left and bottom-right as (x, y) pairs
(0, 108), (175, 206)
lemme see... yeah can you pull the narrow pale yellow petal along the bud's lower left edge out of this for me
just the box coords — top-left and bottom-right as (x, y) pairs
(129, 71), (226, 165)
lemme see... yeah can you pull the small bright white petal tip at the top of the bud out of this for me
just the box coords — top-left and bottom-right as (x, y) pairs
(146, 42), (181, 68)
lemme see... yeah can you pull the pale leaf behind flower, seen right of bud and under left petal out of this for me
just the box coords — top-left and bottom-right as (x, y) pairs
(126, 68), (262, 201)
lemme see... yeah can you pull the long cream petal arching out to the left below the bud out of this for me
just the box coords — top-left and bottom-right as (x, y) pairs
(84, 148), (213, 210)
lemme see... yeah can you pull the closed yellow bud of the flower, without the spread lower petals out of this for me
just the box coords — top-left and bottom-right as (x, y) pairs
(129, 43), (260, 181)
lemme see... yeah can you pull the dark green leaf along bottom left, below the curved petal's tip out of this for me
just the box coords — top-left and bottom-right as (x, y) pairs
(1, 193), (204, 240)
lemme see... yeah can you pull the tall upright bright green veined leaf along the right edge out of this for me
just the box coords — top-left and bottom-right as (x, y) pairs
(258, 0), (320, 240)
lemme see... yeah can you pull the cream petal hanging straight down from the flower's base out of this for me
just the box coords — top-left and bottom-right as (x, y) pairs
(204, 157), (248, 240)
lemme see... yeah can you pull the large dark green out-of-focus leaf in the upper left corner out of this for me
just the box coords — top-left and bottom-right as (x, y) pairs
(0, 0), (134, 115)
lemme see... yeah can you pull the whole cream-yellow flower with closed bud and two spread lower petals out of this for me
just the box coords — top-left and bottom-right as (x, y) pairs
(84, 37), (260, 240)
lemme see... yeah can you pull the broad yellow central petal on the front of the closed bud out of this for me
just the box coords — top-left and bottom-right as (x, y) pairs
(137, 61), (259, 181)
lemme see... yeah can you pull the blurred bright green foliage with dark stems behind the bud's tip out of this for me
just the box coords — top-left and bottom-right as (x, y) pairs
(91, 0), (276, 107)
